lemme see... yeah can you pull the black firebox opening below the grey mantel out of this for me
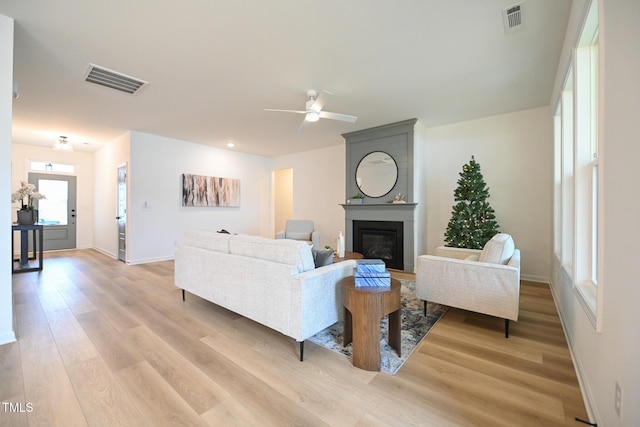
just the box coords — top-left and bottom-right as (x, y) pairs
(353, 221), (404, 270)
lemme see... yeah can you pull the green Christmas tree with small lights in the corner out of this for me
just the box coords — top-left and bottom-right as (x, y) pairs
(444, 156), (499, 249)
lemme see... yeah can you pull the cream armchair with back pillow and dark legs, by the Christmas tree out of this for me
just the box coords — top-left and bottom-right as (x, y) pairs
(416, 233), (520, 338)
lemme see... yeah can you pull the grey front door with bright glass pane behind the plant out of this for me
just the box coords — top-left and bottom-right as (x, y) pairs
(29, 173), (77, 251)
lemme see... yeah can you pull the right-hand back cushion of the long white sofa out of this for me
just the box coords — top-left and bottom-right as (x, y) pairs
(229, 234), (315, 273)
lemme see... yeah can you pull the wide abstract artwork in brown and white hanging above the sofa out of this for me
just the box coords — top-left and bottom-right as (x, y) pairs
(182, 173), (240, 207)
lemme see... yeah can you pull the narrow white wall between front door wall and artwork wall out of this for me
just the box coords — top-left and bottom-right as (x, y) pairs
(93, 132), (130, 258)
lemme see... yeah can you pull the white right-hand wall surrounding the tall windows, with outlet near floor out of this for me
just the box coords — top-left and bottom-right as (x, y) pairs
(551, 0), (640, 426)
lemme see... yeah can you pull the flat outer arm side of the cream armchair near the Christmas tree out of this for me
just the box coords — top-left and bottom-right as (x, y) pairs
(416, 255), (520, 320)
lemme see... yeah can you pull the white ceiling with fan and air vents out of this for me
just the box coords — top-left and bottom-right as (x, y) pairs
(0, 0), (571, 156)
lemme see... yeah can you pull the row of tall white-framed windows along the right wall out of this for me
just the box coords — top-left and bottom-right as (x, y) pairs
(554, 0), (602, 330)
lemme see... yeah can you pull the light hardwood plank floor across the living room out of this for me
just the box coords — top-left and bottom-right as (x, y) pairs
(0, 250), (587, 427)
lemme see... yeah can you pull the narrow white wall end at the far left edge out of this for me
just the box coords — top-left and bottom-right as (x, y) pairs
(0, 15), (16, 344)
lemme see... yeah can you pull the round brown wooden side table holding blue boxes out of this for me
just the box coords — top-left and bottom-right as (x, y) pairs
(341, 276), (402, 371)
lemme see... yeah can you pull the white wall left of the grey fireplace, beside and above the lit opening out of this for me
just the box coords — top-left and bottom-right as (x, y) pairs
(271, 145), (346, 248)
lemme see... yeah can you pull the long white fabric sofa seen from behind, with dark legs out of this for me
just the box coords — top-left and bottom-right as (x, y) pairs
(175, 229), (355, 360)
